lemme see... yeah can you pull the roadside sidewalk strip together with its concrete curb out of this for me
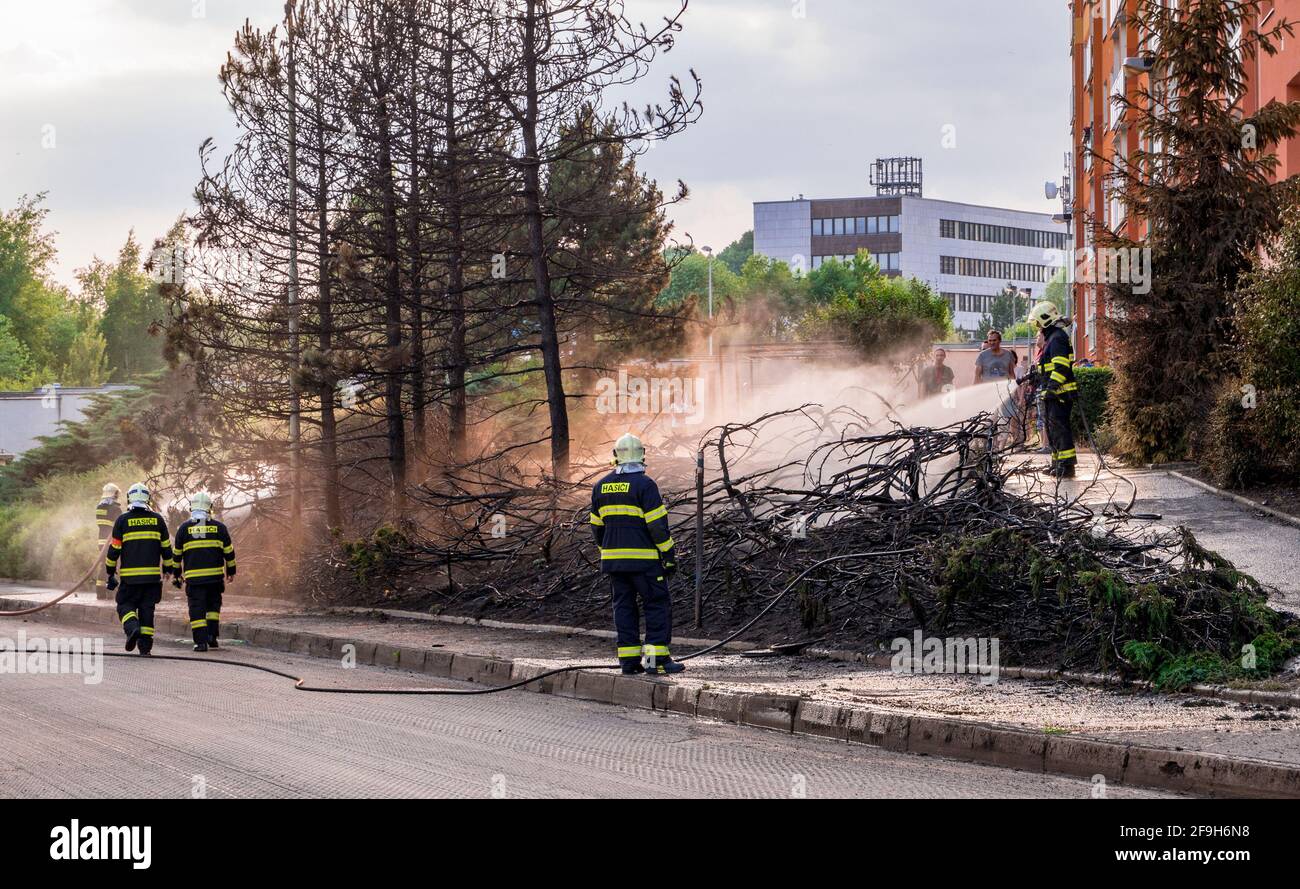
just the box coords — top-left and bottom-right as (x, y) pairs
(0, 585), (1300, 797)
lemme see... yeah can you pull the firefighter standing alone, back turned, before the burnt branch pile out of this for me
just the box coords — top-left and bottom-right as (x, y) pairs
(592, 433), (686, 676)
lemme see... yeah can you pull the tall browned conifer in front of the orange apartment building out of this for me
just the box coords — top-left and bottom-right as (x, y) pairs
(1097, 0), (1300, 463)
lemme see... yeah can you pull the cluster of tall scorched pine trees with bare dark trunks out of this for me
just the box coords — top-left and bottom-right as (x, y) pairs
(159, 0), (702, 526)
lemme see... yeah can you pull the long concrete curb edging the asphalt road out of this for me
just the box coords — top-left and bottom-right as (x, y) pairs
(0, 598), (1300, 798)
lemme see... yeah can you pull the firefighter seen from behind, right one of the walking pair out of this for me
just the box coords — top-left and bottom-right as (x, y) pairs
(172, 491), (235, 651)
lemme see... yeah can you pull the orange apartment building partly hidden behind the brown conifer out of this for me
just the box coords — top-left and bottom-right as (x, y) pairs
(1070, 0), (1300, 361)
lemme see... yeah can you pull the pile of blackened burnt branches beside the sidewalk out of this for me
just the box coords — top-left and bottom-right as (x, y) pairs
(340, 406), (1292, 675)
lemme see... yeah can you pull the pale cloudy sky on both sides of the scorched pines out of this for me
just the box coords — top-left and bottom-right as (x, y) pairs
(0, 0), (1070, 285)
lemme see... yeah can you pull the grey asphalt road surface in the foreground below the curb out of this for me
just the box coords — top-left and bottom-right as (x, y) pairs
(0, 621), (1180, 799)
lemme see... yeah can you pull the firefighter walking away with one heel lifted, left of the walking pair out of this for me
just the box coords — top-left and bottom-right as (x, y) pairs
(104, 482), (176, 656)
